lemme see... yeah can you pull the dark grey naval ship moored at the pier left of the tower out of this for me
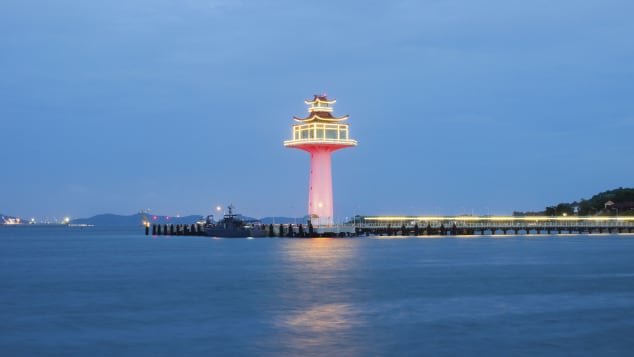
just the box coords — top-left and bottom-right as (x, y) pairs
(205, 205), (268, 238)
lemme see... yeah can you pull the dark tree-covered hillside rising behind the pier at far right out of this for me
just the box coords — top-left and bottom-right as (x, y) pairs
(513, 187), (634, 216)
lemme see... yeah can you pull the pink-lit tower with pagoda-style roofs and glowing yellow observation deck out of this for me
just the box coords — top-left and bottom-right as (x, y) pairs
(284, 94), (357, 226)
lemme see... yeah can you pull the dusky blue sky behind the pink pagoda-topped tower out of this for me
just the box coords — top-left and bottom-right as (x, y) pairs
(0, 0), (634, 219)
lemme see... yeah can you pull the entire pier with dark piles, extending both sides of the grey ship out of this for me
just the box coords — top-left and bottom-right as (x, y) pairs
(145, 216), (634, 238)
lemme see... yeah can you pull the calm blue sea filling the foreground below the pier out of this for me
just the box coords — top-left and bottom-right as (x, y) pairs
(0, 226), (634, 356)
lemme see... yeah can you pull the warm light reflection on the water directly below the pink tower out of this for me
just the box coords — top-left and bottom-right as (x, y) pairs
(264, 238), (364, 355)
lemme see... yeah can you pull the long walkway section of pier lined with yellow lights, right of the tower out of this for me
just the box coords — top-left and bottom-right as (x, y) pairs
(354, 216), (634, 236)
